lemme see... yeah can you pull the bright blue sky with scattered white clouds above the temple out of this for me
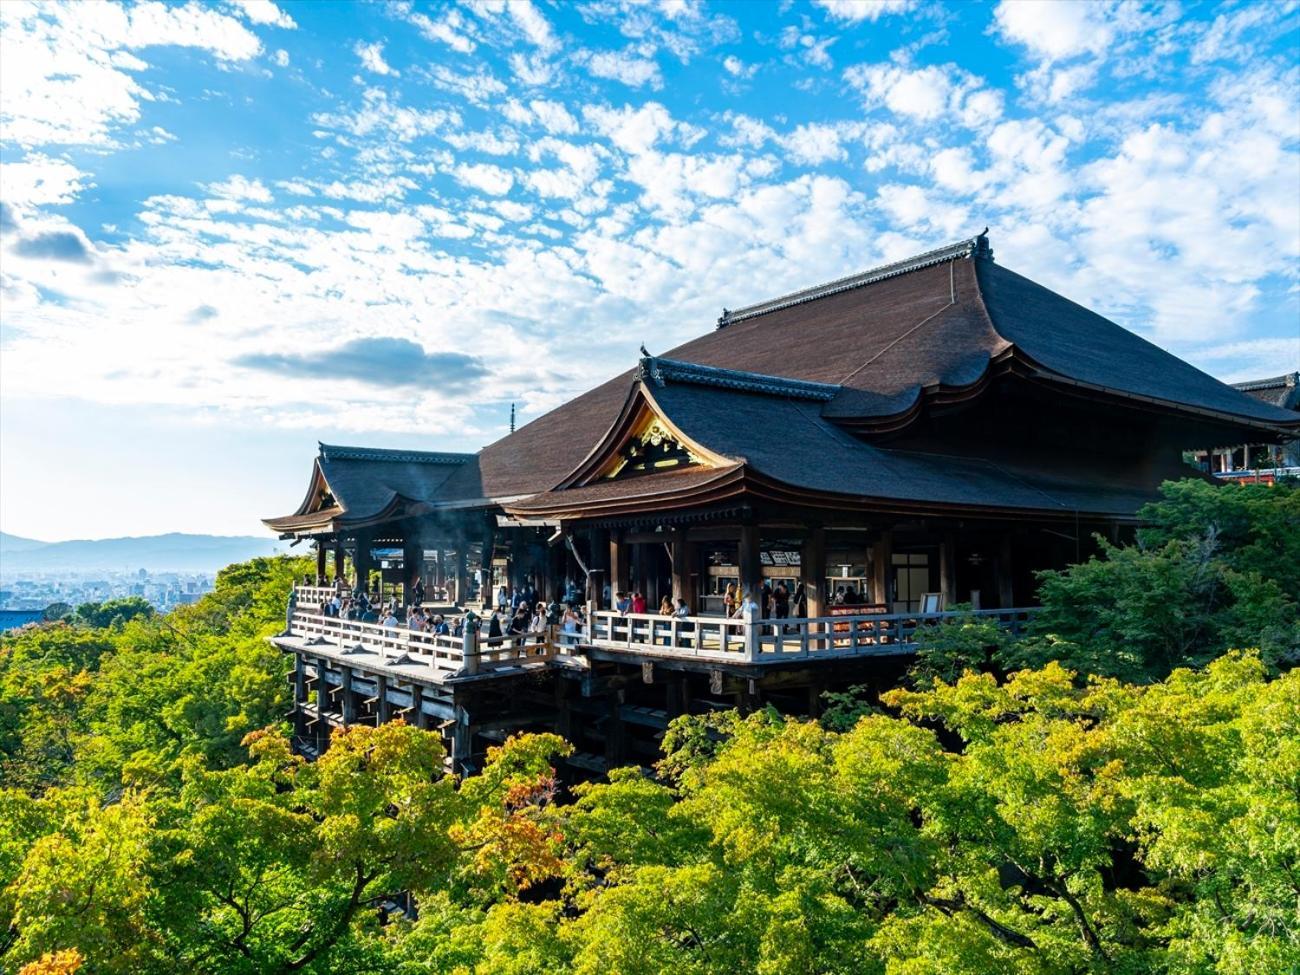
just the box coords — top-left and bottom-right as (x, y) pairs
(0, 0), (1300, 541)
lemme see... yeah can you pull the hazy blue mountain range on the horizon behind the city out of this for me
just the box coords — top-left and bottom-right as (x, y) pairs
(0, 532), (287, 576)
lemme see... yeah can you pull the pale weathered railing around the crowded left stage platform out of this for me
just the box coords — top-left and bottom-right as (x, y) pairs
(286, 610), (559, 680)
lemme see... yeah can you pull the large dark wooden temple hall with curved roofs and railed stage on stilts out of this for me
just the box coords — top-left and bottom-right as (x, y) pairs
(265, 235), (1300, 772)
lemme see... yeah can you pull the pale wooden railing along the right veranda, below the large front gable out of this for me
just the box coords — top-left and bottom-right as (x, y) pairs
(585, 608), (1035, 663)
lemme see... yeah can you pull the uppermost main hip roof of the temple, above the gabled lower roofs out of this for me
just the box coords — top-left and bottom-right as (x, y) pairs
(447, 235), (1297, 499)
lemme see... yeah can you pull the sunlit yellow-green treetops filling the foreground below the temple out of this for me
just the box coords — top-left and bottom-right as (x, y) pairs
(0, 553), (1300, 975)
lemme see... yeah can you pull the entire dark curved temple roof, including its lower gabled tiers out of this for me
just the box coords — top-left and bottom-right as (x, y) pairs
(267, 234), (1300, 530)
